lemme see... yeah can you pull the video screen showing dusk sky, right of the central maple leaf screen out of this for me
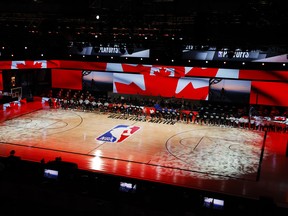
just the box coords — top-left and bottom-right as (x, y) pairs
(209, 79), (251, 104)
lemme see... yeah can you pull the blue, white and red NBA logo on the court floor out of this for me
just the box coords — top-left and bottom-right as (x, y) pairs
(96, 125), (140, 143)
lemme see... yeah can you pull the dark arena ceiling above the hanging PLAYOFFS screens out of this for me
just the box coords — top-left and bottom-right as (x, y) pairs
(0, 0), (288, 59)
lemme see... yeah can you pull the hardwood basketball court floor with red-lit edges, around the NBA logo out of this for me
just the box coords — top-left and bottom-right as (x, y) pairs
(0, 102), (288, 207)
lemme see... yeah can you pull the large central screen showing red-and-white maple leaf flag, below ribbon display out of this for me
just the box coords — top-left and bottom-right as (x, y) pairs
(113, 73), (209, 100)
